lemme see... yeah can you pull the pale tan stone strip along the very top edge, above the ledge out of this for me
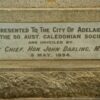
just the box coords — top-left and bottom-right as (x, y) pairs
(0, 0), (100, 8)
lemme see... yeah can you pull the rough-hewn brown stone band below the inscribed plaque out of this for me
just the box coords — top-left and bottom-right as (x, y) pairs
(0, 71), (100, 98)
